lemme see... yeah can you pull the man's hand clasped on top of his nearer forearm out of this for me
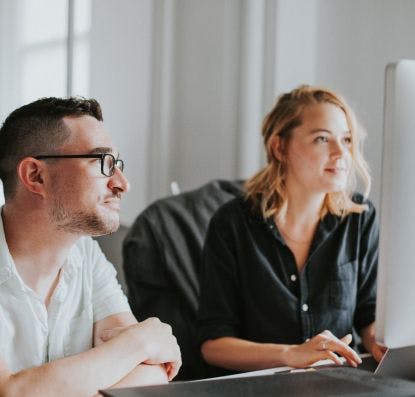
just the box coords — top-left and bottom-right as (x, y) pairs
(101, 318), (182, 380)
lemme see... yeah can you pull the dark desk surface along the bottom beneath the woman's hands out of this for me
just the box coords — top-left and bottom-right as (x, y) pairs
(103, 367), (415, 397)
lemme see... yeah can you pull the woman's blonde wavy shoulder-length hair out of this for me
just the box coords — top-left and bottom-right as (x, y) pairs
(245, 85), (371, 218)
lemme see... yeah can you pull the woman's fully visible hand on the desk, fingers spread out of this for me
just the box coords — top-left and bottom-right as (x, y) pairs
(286, 331), (362, 368)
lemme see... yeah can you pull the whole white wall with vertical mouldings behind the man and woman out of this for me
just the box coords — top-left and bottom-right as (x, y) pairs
(0, 0), (415, 221)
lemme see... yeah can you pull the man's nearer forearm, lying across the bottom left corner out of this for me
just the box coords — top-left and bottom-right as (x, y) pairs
(0, 328), (148, 397)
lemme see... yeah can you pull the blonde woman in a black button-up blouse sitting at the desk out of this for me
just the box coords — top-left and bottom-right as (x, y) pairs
(199, 86), (383, 371)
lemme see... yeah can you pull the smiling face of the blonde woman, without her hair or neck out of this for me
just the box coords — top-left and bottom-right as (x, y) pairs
(282, 103), (352, 193)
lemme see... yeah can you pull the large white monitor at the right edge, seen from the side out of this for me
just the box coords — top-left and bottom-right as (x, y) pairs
(376, 60), (415, 348)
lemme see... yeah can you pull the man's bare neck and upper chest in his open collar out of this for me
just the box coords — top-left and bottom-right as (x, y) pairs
(2, 204), (79, 303)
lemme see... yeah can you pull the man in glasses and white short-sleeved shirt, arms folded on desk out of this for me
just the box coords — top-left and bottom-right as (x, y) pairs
(0, 98), (181, 396)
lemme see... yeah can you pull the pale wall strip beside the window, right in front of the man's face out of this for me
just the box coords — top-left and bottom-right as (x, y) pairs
(90, 0), (153, 224)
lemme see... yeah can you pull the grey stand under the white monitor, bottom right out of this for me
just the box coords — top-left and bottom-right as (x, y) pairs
(375, 346), (415, 381)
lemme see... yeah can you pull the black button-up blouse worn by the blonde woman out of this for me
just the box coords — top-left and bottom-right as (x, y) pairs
(198, 195), (378, 344)
